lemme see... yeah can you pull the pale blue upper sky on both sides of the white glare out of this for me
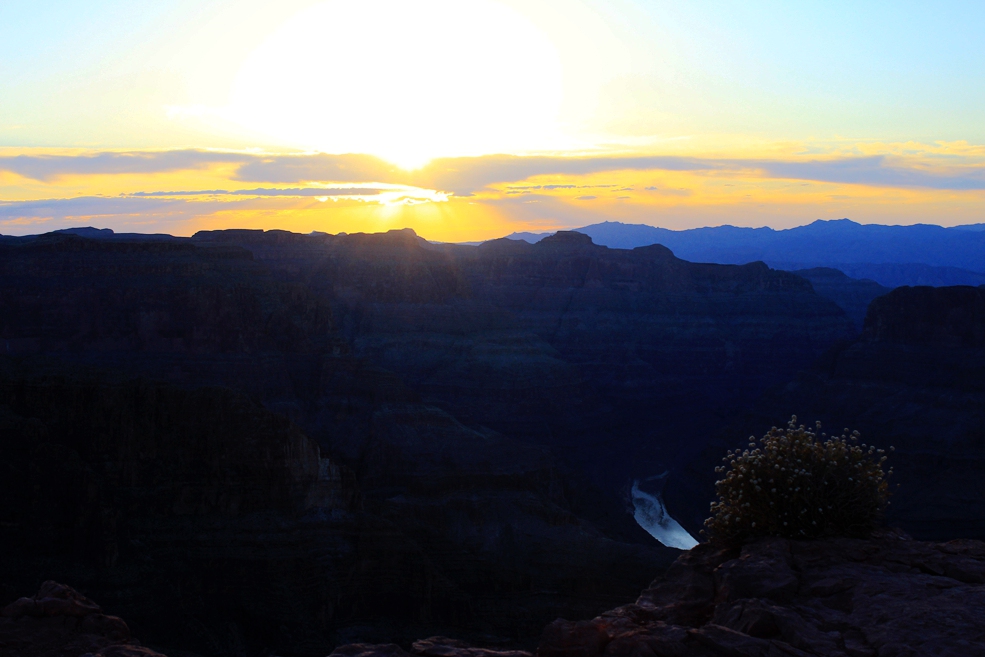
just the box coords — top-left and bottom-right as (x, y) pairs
(7, 0), (985, 147)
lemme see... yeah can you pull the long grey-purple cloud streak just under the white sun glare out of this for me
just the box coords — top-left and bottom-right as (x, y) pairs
(0, 150), (985, 196)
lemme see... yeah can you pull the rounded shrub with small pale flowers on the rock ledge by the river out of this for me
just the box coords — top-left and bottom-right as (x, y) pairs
(704, 415), (893, 544)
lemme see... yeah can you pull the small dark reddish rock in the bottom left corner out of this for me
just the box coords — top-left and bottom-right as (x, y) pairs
(0, 581), (164, 657)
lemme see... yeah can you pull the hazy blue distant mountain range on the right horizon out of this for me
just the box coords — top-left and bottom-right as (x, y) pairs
(508, 219), (985, 287)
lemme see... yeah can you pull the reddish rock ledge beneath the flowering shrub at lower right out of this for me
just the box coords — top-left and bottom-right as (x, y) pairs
(333, 532), (985, 657)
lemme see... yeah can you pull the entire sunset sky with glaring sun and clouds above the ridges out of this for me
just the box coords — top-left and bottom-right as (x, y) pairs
(0, 0), (985, 241)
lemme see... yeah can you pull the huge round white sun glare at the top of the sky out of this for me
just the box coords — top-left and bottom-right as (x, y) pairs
(227, 0), (562, 169)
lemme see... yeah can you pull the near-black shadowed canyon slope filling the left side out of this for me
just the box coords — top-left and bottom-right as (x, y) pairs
(0, 229), (669, 654)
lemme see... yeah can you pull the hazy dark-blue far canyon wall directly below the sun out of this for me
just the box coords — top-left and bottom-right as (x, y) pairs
(217, 231), (854, 490)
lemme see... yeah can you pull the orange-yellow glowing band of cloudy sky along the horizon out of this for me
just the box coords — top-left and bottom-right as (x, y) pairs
(0, 142), (985, 242)
